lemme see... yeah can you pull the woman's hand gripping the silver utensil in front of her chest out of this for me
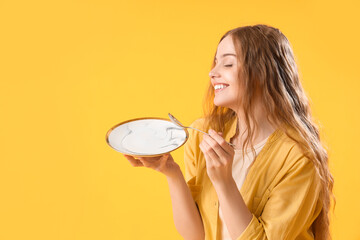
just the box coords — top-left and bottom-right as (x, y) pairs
(199, 129), (235, 187)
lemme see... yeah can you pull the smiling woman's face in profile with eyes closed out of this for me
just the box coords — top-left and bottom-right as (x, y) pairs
(209, 35), (240, 110)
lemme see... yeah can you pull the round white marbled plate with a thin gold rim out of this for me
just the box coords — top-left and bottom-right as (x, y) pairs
(106, 117), (189, 157)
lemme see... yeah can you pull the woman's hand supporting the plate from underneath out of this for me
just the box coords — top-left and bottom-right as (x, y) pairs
(123, 153), (180, 177)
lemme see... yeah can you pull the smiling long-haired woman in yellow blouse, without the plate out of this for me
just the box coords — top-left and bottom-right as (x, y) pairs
(125, 25), (335, 240)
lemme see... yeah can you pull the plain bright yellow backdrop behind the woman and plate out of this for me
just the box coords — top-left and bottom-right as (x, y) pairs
(0, 0), (360, 240)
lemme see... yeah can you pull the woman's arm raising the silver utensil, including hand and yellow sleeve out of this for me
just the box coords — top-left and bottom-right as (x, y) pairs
(200, 129), (322, 240)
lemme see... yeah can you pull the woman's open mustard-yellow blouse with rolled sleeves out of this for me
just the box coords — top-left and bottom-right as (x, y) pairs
(184, 118), (322, 240)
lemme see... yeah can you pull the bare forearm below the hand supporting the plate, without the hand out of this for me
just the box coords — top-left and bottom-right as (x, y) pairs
(167, 168), (205, 240)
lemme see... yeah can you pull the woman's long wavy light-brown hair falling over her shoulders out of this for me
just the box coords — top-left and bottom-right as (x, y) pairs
(203, 24), (336, 240)
